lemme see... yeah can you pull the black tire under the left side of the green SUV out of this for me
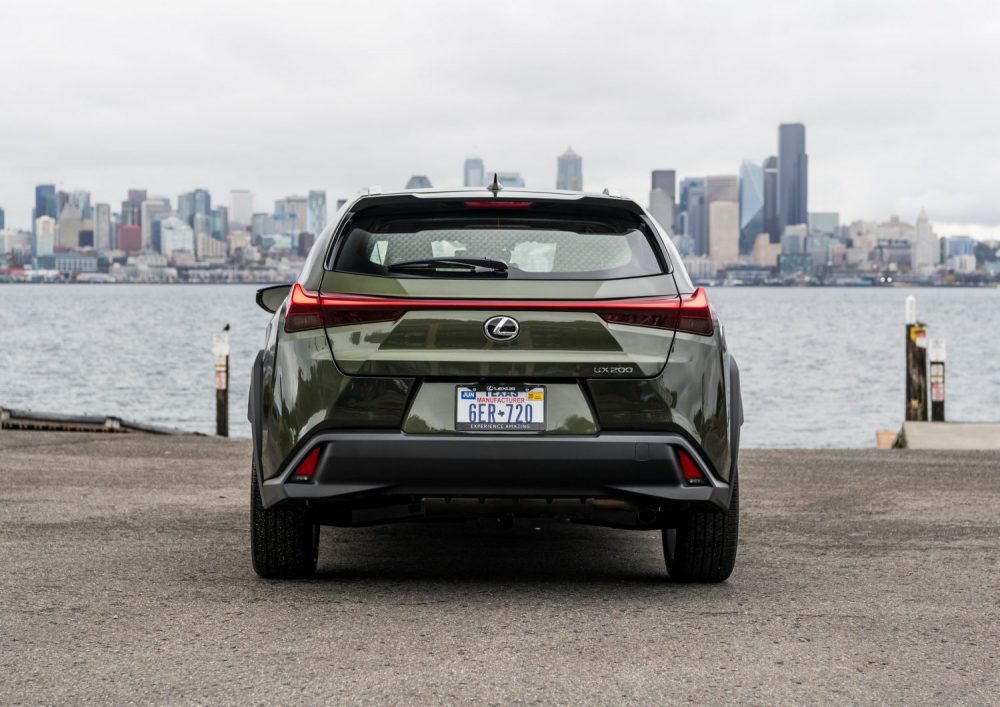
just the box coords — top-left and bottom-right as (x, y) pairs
(250, 462), (319, 579)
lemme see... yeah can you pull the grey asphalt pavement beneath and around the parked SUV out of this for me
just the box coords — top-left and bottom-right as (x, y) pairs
(0, 431), (1000, 705)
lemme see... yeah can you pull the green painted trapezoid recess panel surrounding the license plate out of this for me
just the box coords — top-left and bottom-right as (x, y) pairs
(403, 380), (598, 435)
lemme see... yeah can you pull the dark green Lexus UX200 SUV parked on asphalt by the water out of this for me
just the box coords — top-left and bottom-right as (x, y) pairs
(249, 184), (743, 582)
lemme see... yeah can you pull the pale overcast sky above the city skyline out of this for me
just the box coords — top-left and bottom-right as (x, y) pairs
(0, 0), (1000, 237)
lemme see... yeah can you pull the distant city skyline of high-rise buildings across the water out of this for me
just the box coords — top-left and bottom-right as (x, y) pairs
(0, 134), (1000, 284)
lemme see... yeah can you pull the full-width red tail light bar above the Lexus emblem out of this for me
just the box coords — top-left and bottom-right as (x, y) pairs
(285, 283), (713, 336)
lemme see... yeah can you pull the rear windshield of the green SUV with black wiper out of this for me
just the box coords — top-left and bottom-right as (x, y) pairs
(334, 213), (665, 280)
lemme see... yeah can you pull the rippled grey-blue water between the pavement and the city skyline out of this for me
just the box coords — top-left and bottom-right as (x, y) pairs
(0, 285), (1000, 447)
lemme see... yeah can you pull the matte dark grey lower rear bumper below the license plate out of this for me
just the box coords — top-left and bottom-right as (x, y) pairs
(261, 431), (730, 509)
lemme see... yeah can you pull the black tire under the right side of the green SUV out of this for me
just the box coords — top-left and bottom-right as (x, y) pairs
(663, 473), (740, 582)
